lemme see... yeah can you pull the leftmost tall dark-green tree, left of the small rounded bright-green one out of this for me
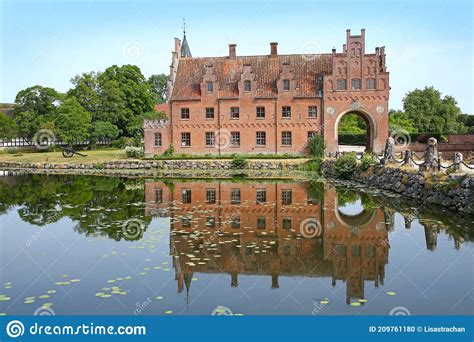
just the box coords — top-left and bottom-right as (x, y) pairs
(14, 85), (62, 138)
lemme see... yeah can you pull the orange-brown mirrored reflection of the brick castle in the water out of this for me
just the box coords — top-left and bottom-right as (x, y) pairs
(145, 182), (389, 302)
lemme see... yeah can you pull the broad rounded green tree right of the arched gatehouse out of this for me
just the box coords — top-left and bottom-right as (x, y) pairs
(403, 87), (466, 135)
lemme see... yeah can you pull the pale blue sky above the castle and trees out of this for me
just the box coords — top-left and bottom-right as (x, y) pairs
(0, 0), (474, 113)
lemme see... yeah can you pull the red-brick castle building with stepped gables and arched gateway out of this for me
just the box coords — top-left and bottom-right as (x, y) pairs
(145, 30), (390, 155)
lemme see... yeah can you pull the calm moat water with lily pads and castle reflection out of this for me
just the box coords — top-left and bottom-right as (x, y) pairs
(0, 175), (474, 315)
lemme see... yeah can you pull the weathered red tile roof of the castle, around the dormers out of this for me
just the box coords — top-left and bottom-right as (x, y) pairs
(171, 54), (332, 101)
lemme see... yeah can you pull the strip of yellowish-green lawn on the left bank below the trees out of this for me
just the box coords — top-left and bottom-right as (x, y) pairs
(0, 150), (129, 163)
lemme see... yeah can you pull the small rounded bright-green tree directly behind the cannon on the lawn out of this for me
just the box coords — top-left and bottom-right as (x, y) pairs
(55, 97), (91, 144)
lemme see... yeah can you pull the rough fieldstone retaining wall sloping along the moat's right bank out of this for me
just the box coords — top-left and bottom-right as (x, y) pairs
(324, 161), (474, 214)
